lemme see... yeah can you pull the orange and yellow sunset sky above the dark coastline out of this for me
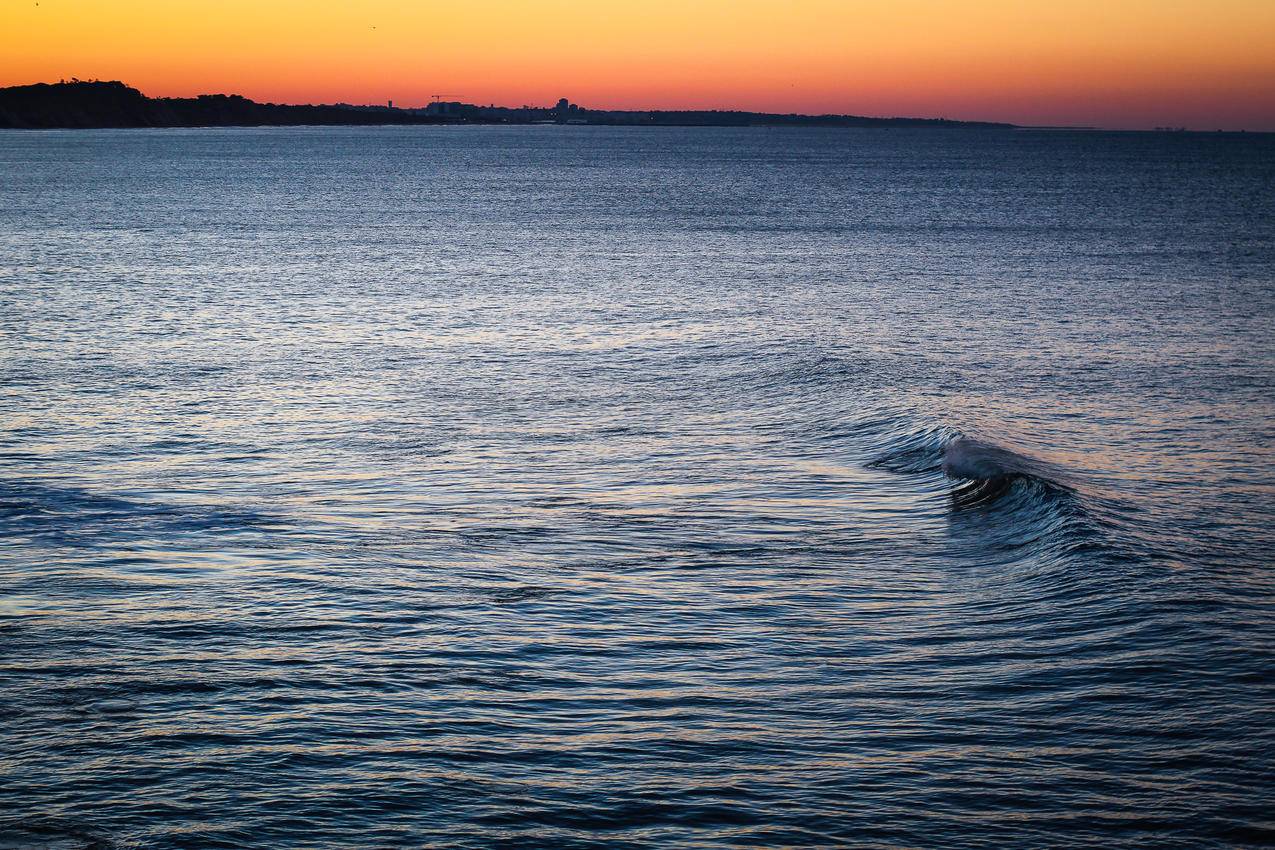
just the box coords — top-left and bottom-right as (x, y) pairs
(7, 0), (1275, 130)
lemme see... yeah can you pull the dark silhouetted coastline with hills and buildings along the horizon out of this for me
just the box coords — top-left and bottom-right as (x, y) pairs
(0, 80), (1015, 130)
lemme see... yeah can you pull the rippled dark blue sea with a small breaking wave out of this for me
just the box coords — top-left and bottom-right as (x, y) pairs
(0, 127), (1275, 850)
